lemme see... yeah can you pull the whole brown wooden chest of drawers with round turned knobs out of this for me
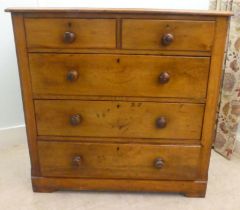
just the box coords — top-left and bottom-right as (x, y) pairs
(7, 8), (230, 197)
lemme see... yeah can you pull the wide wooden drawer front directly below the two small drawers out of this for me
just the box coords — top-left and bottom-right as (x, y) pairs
(29, 53), (210, 98)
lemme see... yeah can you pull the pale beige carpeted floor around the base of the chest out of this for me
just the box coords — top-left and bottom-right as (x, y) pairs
(0, 141), (240, 210)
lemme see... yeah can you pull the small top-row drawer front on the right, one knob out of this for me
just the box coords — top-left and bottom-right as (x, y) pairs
(122, 19), (215, 51)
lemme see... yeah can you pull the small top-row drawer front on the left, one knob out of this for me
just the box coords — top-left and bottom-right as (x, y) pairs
(25, 18), (116, 48)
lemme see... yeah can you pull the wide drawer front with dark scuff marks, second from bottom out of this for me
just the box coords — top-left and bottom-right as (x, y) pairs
(35, 100), (204, 139)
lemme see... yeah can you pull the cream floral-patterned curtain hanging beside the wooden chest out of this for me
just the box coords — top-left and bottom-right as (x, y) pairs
(209, 0), (240, 159)
